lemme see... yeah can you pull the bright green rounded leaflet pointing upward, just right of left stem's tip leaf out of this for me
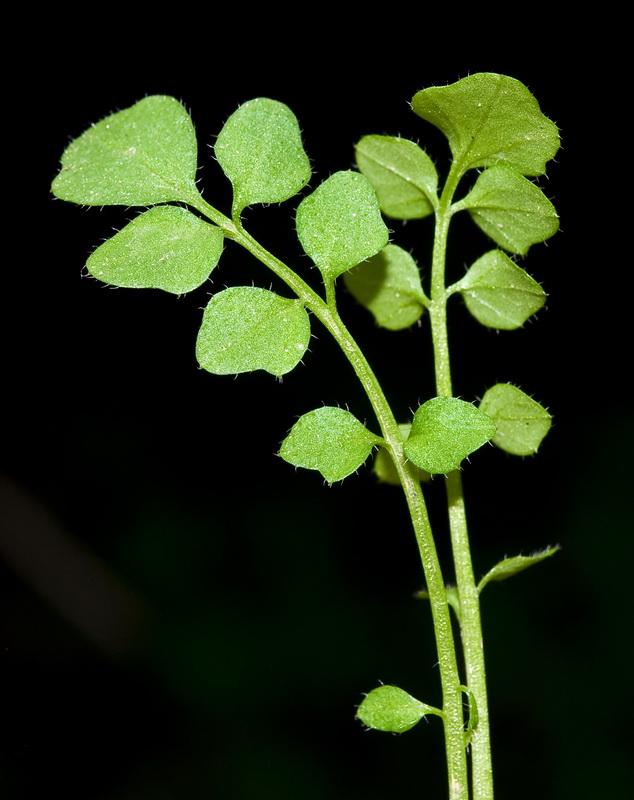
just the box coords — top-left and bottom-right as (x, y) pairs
(214, 97), (311, 218)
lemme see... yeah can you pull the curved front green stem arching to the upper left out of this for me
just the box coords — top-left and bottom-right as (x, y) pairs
(192, 198), (469, 800)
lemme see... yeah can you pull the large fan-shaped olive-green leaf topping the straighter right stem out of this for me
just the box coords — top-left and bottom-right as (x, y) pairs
(412, 72), (559, 175)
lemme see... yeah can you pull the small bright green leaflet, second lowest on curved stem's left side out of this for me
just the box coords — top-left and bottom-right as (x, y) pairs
(280, 406), (382, 483)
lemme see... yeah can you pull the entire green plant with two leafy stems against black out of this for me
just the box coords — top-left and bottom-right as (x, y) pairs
(52, 74), (559, 800)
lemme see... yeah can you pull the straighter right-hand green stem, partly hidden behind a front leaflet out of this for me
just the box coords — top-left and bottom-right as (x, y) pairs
(429, 170), (493, 800)
